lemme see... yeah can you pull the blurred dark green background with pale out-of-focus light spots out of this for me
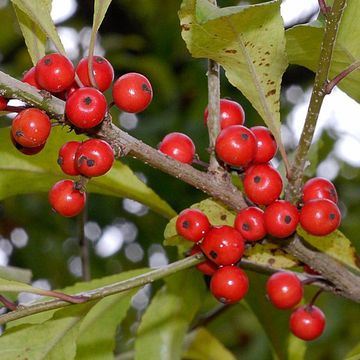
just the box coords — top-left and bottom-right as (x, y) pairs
(0, 0), (360, 360)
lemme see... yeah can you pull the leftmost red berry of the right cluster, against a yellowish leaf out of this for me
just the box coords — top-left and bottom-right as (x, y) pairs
(176, 209), (211, 242)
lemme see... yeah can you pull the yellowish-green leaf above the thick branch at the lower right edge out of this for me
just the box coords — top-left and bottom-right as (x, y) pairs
(296, 226), (360, 272)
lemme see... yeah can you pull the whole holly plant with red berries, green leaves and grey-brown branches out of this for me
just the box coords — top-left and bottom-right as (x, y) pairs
(0, 0), (360, 360)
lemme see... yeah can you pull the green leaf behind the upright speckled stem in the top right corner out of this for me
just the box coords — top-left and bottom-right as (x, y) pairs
(286, 1), (360, 102)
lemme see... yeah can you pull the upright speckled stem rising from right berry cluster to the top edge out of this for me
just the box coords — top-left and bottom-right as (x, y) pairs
(286, 0), (346, 202)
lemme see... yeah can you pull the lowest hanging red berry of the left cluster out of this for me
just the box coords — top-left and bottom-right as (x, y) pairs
(49, 180), (86, 217)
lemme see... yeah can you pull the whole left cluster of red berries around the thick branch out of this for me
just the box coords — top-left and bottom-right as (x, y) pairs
(7, 53), (153, 217)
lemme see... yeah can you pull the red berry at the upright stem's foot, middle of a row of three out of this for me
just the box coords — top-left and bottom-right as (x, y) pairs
(264, 200), (299, 239)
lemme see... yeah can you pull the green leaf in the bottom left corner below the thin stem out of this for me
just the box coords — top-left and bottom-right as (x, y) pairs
(0, 304), (91, 360)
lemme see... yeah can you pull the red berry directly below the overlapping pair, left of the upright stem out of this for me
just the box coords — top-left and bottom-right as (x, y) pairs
(243, 164), (283, 205)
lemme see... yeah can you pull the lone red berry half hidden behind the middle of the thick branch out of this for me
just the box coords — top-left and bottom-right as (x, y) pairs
(159, 132), (195, 164)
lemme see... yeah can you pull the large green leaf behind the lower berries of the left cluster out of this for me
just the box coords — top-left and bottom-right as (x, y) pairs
(0, 127), (176, 218)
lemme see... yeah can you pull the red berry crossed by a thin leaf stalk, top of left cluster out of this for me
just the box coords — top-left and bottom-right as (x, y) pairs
(76, 56), (114, 92)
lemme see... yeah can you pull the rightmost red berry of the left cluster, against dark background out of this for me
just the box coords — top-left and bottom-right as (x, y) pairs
(112, 73), (153, 113)
